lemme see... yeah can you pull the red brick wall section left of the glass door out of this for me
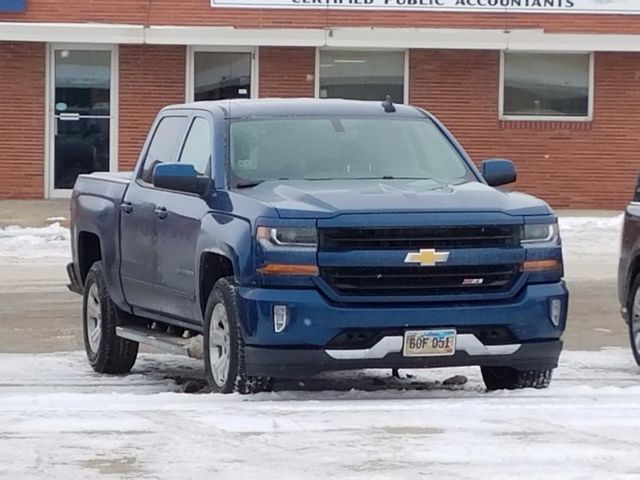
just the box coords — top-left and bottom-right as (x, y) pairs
(0, 42), (45, 198)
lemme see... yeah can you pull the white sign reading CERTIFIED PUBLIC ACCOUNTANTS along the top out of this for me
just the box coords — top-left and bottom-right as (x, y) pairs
(211, 0), (640, 15)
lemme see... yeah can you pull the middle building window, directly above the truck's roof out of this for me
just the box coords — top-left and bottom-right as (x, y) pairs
(318, 50), (405, 103)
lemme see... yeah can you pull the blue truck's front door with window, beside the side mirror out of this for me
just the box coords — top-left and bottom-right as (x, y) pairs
(155, 112), (213, 323)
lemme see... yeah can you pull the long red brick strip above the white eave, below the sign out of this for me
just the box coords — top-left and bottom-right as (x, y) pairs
(0, 0), (640, 34)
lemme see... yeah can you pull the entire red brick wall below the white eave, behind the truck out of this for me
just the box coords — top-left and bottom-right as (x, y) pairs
(0, 42), (640, 208)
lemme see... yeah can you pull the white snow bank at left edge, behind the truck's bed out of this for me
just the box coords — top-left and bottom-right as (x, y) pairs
(0, 222), (71, 263)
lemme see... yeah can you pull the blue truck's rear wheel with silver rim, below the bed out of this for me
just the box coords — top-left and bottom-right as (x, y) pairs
(82, 262), (138, 373)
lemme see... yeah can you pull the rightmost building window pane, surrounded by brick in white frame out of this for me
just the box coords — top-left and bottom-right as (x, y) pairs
(502, 52), (592, 119)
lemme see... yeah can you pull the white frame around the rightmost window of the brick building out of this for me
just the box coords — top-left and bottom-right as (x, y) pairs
(498, 50), (595, 122)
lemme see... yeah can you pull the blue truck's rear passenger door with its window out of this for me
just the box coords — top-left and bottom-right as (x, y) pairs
(120, 115), (188, 311)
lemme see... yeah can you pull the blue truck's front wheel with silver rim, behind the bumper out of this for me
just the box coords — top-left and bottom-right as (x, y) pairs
(204, 278), (273, 394)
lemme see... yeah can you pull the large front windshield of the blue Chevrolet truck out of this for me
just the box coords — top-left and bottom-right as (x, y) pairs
(230, 117), (476, 186)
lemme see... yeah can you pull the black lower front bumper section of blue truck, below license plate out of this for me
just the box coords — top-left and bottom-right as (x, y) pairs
(245, 335), (562, 378)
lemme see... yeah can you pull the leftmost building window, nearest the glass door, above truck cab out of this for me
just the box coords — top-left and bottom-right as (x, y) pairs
(193, 51), (252, 101)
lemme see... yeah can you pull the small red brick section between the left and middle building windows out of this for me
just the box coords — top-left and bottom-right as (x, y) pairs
(258, 47), (316, 97)
